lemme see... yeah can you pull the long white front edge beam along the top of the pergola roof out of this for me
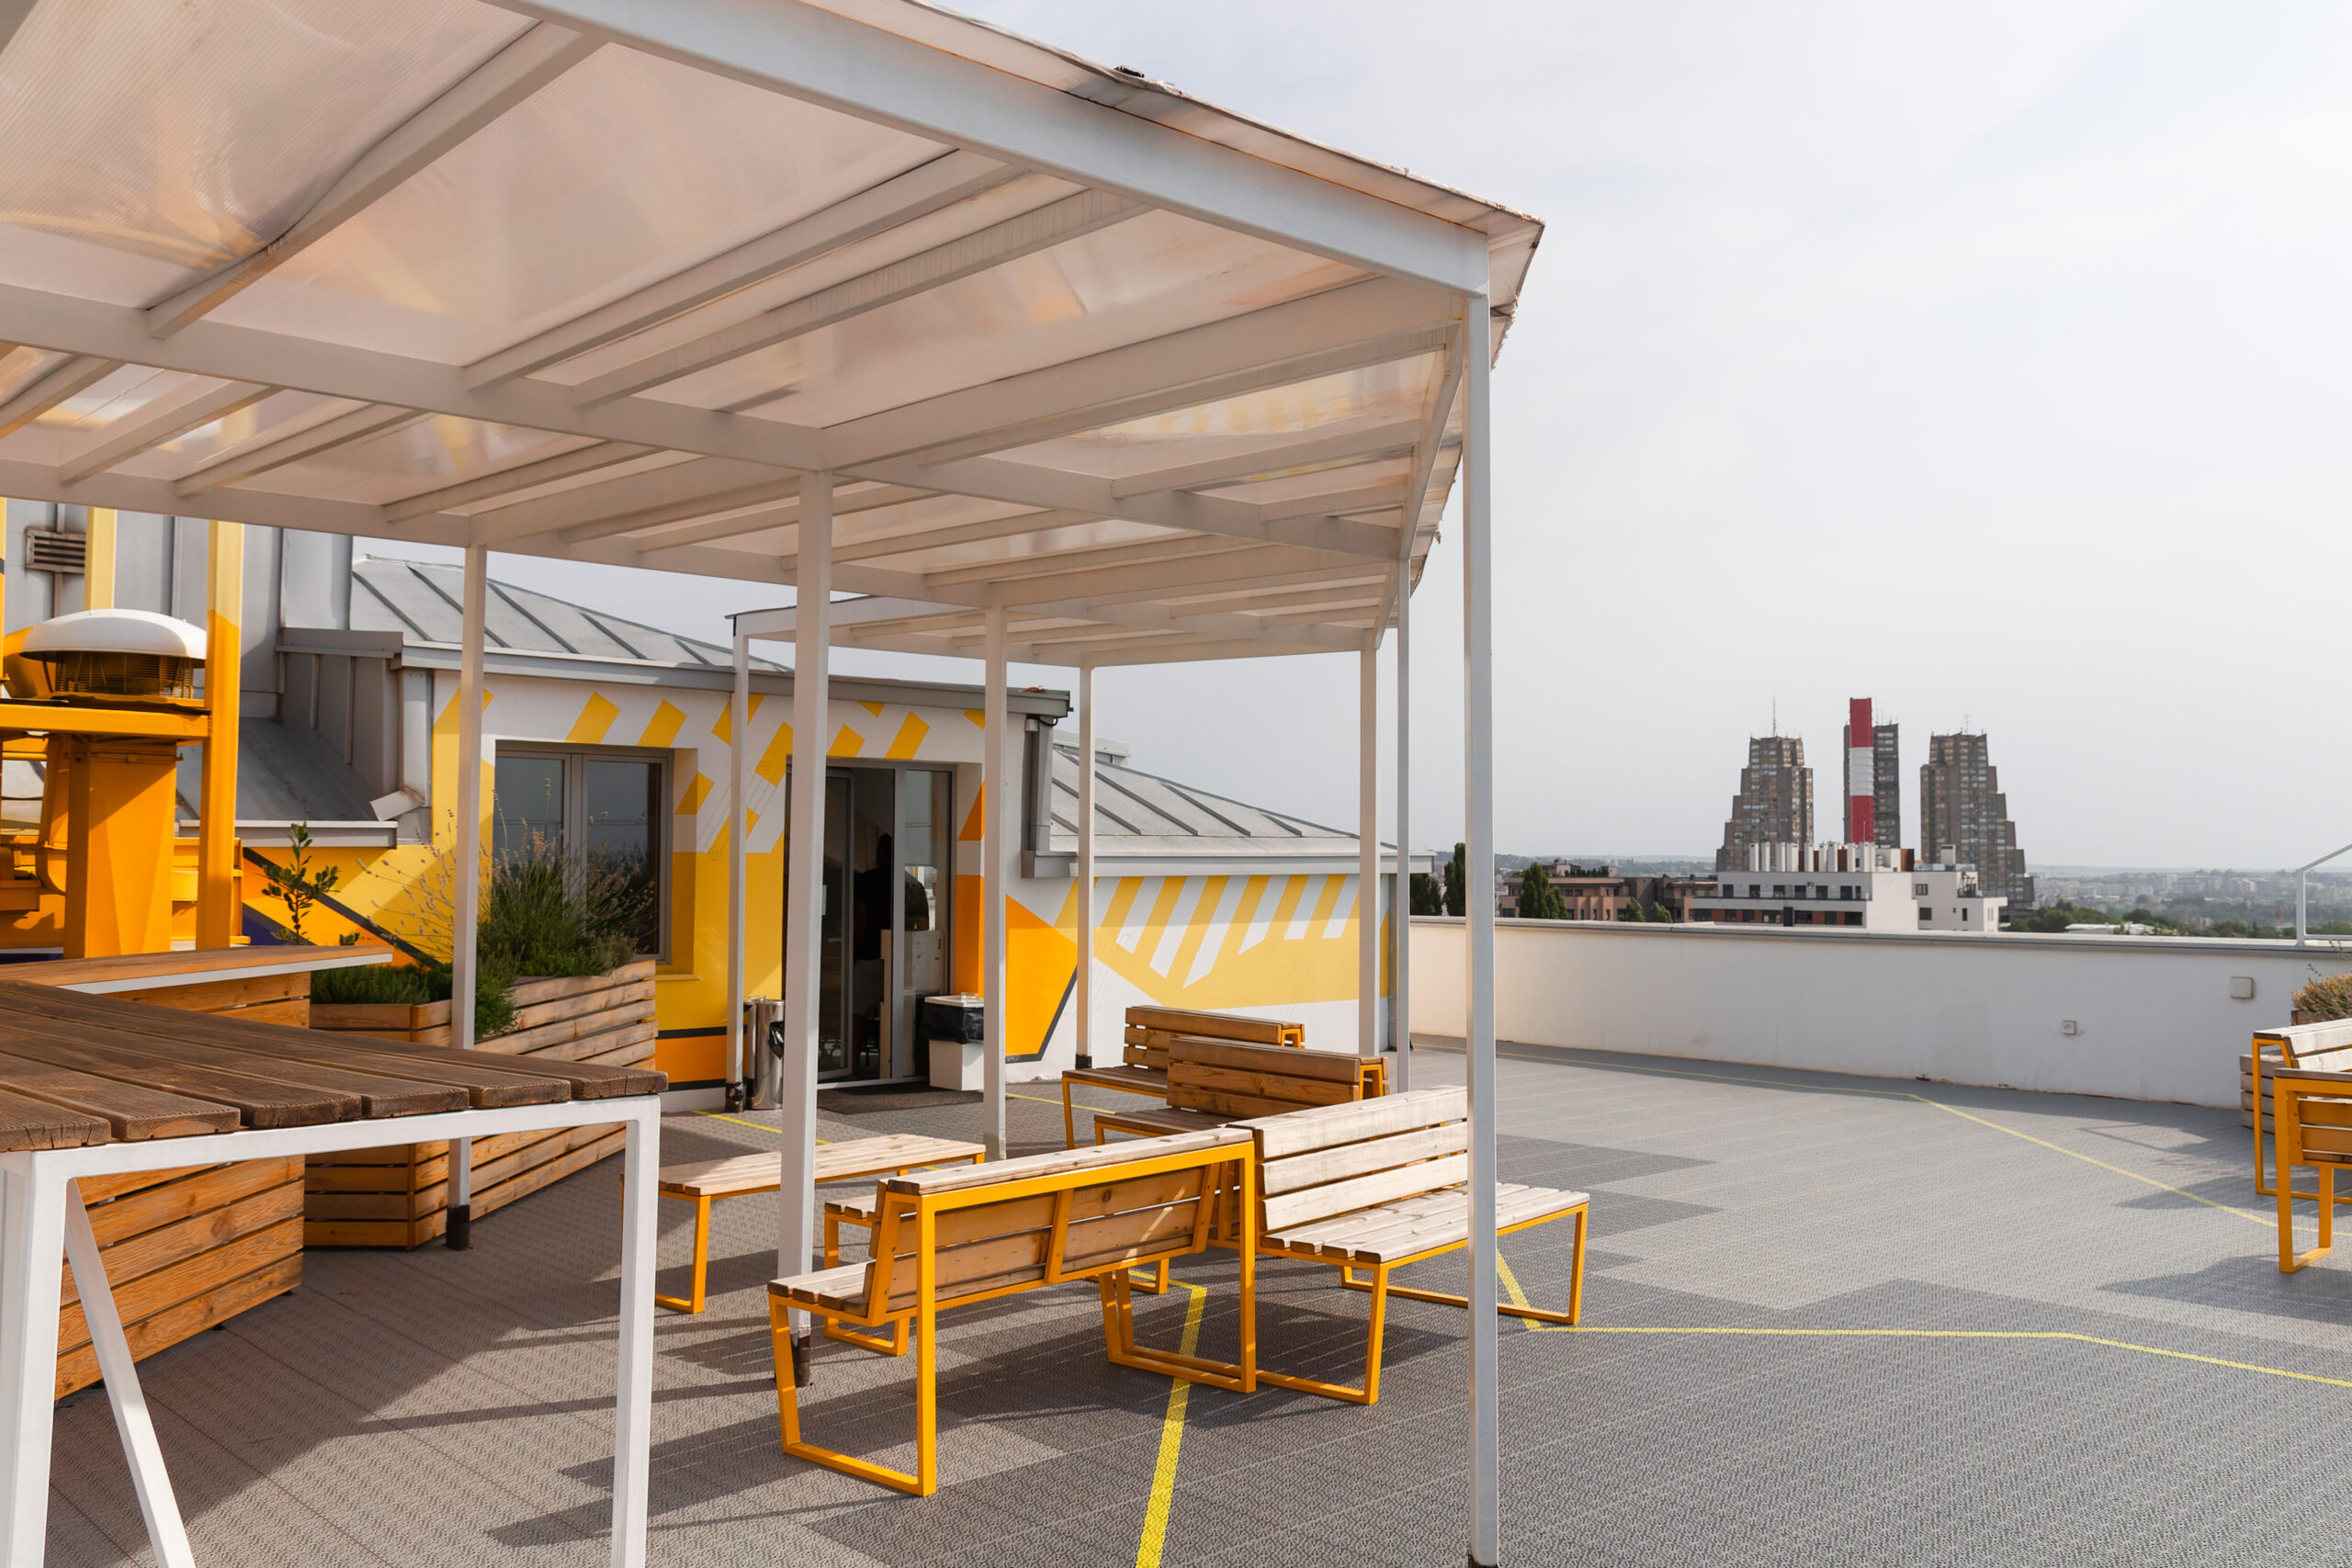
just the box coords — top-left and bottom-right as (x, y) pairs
(492, 0), (1491, 294)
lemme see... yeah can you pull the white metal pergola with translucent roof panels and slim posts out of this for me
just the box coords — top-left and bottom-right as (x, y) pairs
(0, 0), (1541, 1563)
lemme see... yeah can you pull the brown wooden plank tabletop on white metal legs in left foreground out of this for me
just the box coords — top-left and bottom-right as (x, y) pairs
(0, 978), (668, 1152)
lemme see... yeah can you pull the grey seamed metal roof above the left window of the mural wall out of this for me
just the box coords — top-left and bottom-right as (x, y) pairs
(350, 555), (786, 670)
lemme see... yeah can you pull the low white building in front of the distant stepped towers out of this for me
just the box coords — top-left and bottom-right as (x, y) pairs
(1689, 844), (2004, 936)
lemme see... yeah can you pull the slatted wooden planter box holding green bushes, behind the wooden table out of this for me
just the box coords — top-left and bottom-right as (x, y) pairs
(303, 959), (654, 1248)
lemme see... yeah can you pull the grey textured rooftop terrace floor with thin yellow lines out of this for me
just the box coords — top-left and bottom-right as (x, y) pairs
(50, 1046), (2352, 1568)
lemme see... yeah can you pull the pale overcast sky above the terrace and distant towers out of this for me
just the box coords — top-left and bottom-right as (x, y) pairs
(407, 0), (2352, 867)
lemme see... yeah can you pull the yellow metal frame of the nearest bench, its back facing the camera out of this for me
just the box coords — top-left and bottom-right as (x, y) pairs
(767, 1140), (1259, 1497)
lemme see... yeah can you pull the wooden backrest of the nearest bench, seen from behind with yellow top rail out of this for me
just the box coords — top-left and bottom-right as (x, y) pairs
(865, 1128), (1251, 1312)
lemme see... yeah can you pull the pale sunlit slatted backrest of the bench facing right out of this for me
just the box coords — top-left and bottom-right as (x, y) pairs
(1235, 1089), (1470, 1235)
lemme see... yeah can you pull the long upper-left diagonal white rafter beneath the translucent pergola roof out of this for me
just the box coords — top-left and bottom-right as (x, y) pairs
(146, 24), (605, 336)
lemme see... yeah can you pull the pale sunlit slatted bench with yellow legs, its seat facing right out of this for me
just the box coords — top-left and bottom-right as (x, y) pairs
(1235, 1089), (1590, 1405)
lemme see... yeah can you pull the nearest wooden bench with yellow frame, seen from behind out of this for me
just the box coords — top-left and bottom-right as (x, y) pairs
(767, 1128), (1259, 1497)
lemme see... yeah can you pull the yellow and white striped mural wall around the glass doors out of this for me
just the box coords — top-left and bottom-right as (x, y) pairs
(247, 670), (1385, 1086)
